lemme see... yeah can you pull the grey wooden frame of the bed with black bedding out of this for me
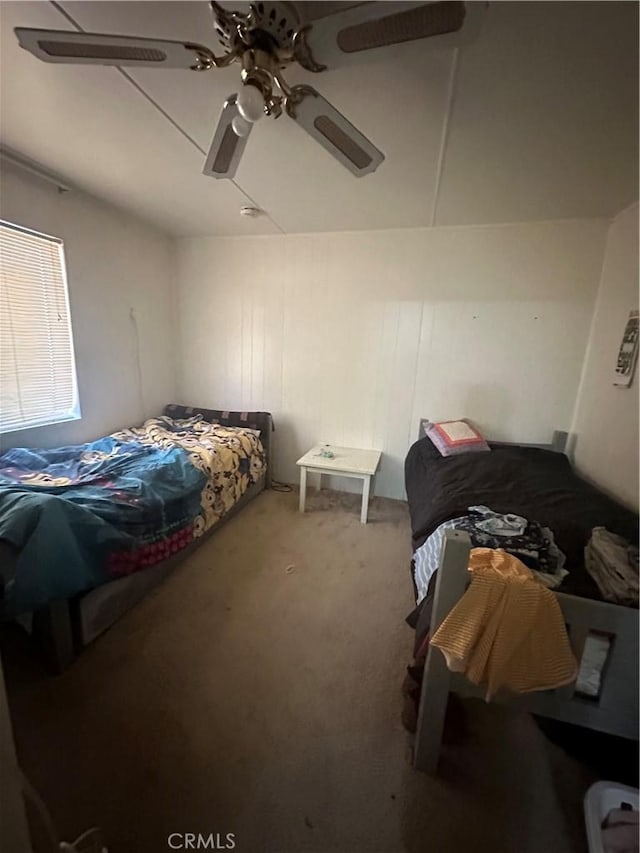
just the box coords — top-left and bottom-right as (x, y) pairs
(413, 420), (638, 774)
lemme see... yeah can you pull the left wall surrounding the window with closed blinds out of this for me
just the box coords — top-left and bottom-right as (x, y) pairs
(0, 162), (175, 447)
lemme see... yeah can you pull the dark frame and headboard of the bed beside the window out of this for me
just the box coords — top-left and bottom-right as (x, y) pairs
(8, 404), (274, 673)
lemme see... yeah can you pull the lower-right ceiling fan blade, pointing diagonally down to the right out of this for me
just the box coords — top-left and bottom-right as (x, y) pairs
(287, 86), (384, 178)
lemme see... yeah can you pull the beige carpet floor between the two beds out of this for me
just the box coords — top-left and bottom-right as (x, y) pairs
(4, 492), (608, 853)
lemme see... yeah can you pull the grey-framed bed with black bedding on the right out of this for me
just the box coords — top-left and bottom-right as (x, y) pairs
(405, 421), (638, 773)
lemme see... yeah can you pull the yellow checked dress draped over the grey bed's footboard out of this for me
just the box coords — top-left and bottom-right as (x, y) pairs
(431, 548), (578, 701)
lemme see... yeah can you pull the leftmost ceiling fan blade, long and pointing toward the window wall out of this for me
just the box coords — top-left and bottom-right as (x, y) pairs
(15, 27), (211, 68)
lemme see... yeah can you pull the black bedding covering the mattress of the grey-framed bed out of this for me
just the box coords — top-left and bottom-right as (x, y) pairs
(405, 438), (638, 599)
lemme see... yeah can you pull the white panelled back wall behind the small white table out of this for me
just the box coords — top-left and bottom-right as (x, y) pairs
(178, 220), (608, 497)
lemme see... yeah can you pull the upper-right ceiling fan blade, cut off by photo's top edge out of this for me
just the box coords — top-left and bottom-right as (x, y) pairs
(303, 0), (488, 68)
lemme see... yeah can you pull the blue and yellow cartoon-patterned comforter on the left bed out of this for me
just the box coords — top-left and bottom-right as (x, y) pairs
(0, 416), (266, 616)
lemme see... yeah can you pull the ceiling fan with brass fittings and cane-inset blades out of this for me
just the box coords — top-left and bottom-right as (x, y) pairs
(15, 0), (487, 178)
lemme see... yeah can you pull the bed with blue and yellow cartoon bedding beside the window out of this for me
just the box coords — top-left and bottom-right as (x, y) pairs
(0, 404), (273, 671)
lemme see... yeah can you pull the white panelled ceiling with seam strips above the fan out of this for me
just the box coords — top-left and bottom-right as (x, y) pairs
(0, 0), (638, 235)
